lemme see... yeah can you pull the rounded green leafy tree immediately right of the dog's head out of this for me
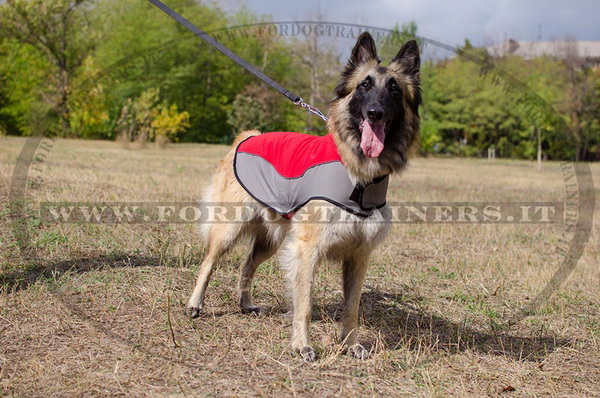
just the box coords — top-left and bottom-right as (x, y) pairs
(421, 41), (535, 158)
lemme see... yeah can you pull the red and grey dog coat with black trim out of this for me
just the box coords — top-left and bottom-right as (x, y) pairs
(233, 132), (389, 218)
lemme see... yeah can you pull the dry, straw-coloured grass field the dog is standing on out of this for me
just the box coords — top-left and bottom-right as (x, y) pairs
(0, 137), (600, 397)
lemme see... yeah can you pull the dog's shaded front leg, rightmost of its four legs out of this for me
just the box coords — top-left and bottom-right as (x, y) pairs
(340, 253), (369, 359)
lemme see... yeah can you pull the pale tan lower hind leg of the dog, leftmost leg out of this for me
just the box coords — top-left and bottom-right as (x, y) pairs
(187, 223), (242, 318)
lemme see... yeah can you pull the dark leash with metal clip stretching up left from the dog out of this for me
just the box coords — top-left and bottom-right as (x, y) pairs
(148, 0), (327, 121)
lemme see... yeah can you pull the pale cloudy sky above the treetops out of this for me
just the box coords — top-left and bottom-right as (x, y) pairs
(219, 0), (600, 46)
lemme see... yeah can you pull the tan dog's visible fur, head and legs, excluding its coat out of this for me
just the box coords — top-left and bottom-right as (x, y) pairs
(188, 32), (421, 361)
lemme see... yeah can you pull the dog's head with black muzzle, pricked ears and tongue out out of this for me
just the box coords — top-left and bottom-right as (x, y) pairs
(329, 32), (421, 179)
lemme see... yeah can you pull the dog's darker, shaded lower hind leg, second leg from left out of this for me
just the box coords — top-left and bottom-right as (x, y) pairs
(238, 233), (277, 314)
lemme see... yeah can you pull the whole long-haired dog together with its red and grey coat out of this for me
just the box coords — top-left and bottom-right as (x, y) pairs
(187, 32), (421, 361)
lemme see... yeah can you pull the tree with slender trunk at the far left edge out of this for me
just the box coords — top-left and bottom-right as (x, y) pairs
(0, 0), (98, 136)
